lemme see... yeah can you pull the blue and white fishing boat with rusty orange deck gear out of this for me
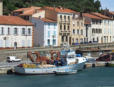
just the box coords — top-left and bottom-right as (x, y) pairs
(14, 49), (87, 75)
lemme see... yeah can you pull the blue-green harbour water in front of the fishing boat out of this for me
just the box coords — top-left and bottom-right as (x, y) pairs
(0, 67), (114, 87)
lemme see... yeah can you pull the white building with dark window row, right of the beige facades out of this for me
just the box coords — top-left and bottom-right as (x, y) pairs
(83, 13), (103, 43)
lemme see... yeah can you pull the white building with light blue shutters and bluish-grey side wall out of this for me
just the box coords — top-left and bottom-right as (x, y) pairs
(32, 18), (58, 46)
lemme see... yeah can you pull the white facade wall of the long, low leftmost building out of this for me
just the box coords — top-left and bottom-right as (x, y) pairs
(0, 25), (33, 48)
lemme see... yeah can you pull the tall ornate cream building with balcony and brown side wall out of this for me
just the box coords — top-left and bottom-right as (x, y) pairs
(44, 7), (75, 46)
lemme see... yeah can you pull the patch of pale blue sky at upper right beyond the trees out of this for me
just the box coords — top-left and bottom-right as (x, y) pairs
(100, 0), (114, 11)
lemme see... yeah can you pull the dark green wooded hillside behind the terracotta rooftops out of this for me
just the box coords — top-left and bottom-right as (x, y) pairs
(3, 0), (101, 15)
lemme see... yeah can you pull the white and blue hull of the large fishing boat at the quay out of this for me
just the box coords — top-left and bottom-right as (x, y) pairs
(14, 63), (85, 75)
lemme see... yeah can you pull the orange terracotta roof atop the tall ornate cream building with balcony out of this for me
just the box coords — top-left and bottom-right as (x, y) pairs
(44, 7), (75, 13)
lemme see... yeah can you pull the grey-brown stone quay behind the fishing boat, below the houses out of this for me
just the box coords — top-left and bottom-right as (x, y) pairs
(0, 43), (114, 74)
